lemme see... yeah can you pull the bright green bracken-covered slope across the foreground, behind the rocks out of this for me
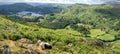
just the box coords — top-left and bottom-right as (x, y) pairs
(0, 16), (118, 54)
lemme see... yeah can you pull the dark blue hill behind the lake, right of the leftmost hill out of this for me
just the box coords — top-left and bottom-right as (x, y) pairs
(26, 4), (63, 14)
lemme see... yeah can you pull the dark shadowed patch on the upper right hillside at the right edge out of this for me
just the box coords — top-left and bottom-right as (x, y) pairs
(95, 7), (120, 19)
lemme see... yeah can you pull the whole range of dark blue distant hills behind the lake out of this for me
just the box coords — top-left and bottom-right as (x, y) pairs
(0, 3), (64, 14)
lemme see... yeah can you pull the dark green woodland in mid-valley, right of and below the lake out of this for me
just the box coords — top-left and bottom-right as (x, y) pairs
(38, 15), (79, 29)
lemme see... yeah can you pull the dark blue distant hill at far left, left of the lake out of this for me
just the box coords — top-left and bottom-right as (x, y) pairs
(0, 3), (32, 14)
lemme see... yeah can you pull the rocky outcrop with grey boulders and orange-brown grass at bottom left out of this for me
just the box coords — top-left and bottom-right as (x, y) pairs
(0, 38), (52, 54)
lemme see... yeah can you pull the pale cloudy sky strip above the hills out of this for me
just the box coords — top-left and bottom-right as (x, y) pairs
(0, 0), (120, 4)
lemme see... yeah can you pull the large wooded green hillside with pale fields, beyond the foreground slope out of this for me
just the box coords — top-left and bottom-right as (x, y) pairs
(38, 4), (120, 41)
